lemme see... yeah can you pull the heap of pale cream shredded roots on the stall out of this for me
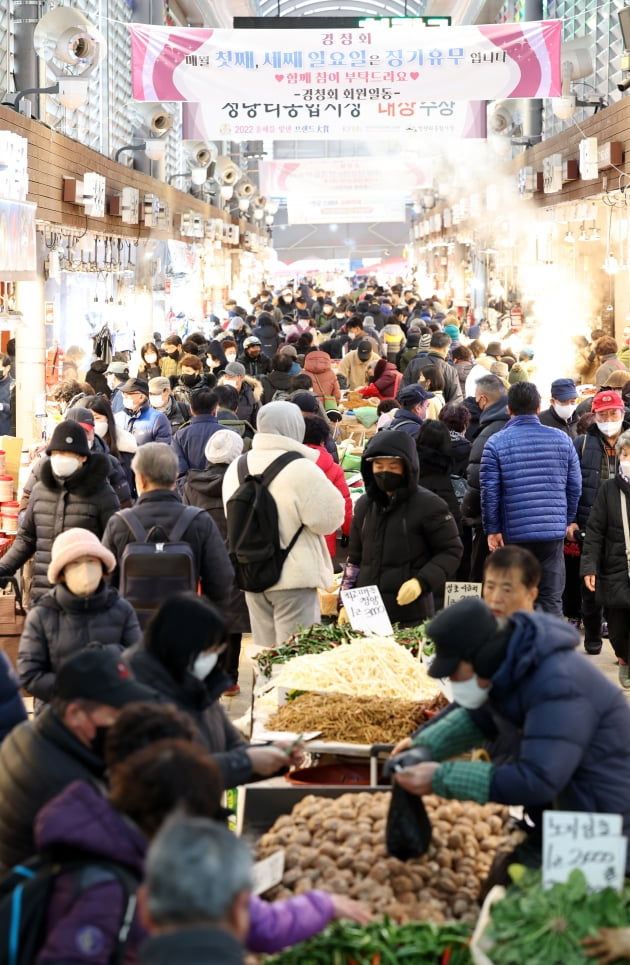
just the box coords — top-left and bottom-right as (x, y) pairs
(273, 637), (440, 701)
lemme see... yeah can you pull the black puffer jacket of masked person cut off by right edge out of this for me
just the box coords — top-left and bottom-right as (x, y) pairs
(580, 474), (630, 607)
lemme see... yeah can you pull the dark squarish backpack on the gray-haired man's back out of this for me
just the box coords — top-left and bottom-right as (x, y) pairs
(118, 506), (205, 629)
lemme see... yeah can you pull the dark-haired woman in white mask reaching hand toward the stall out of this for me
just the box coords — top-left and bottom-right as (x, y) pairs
(124, 593), (302, 787)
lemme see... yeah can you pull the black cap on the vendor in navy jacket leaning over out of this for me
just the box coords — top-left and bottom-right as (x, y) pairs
(427, 599), (512, 679)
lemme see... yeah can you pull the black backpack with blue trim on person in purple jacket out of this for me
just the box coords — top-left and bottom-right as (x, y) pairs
(0, 855), (140, 965)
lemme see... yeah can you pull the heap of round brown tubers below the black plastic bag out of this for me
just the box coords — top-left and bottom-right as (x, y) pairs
(258, 792), (522, 924)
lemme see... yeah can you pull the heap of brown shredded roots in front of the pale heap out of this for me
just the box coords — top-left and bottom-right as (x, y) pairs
(267, 694), (446, 744)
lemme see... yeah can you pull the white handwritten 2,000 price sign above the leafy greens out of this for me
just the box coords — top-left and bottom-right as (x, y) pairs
(542, 811), (628, 891)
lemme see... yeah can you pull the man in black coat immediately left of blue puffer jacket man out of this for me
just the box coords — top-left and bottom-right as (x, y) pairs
(462, 373), (510, 583)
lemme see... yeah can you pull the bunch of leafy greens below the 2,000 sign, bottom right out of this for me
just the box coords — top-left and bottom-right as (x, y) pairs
(487, 869), (630, 965)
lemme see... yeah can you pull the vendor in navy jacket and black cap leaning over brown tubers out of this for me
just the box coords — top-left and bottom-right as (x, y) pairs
(394, 599), (630, 884)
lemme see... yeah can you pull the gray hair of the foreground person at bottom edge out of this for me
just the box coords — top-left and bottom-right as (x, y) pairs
(145, 814), (252, 926)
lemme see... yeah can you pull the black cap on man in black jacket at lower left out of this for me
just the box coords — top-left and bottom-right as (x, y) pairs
(54, 644), (155, 707)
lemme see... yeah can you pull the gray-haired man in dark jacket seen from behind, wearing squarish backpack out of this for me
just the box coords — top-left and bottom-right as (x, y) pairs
(103, 442), (234, 609)
